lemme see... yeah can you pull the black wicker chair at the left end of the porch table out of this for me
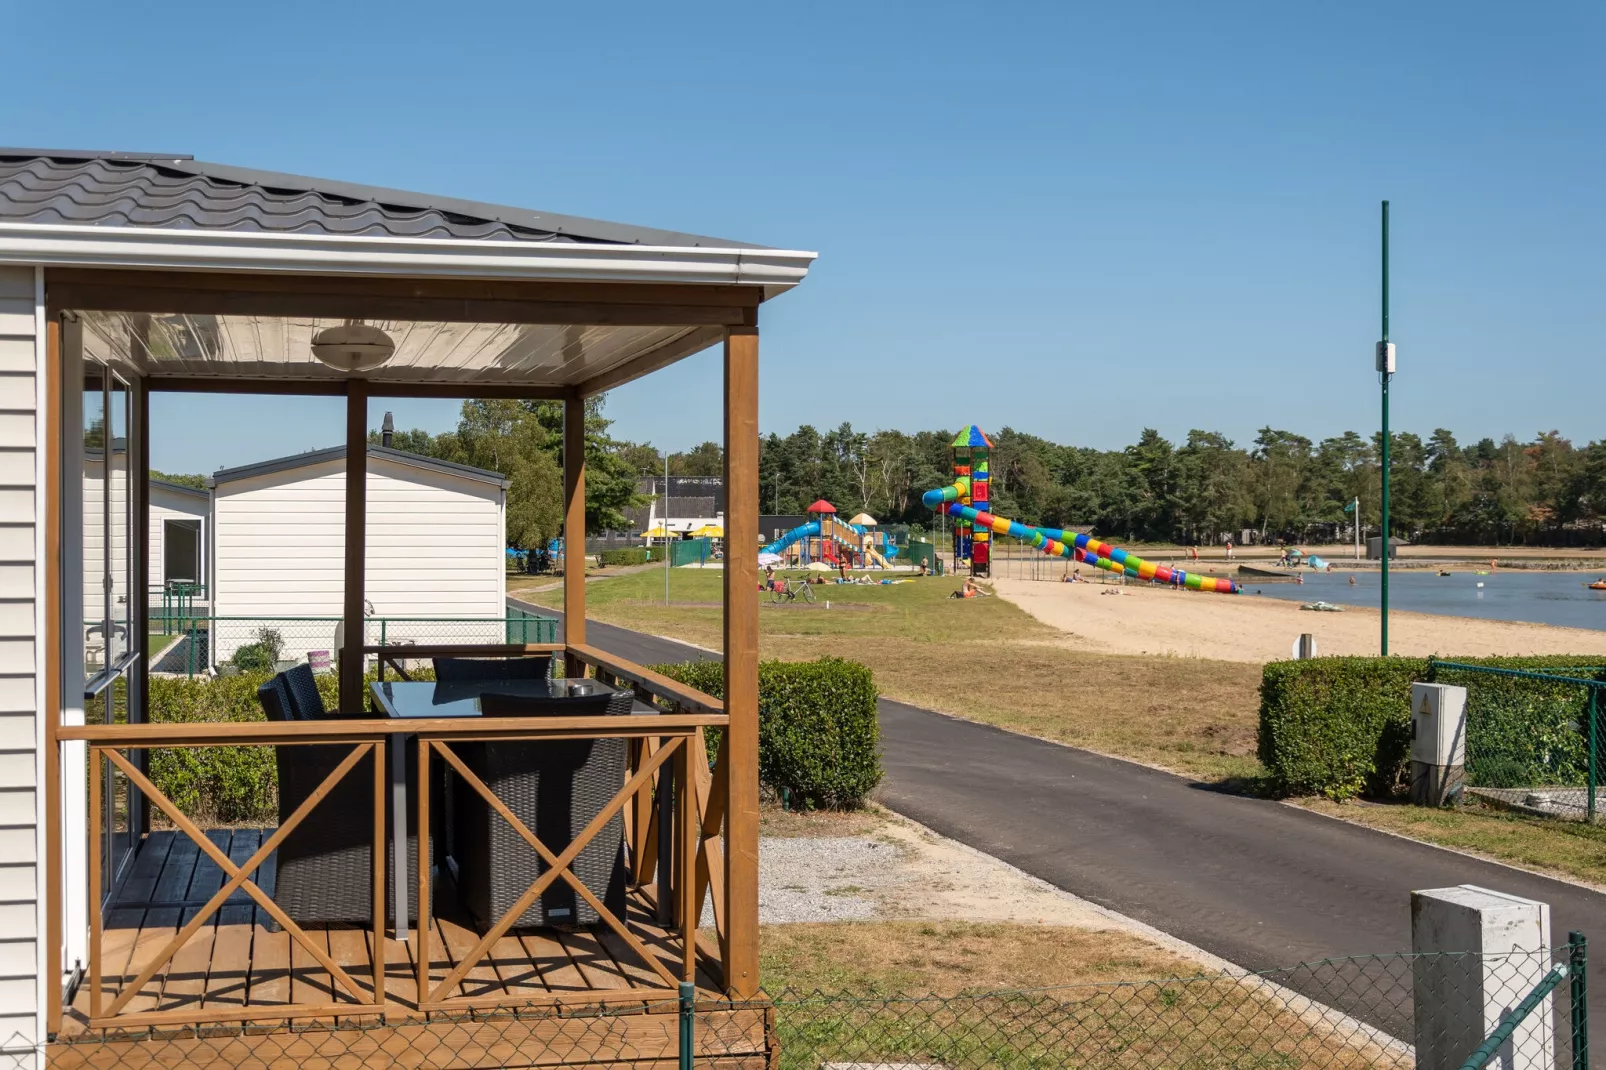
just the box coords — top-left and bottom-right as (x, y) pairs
(257, 665), (418, 927)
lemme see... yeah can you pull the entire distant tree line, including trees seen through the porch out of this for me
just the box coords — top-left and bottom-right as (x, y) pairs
(167, 397), (1606, 548)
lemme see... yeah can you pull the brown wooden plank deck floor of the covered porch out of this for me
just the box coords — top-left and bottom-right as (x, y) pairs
(53, 829), (766, 1067)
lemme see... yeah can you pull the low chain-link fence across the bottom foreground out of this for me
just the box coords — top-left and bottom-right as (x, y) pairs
(51, 937), (1590, 1070)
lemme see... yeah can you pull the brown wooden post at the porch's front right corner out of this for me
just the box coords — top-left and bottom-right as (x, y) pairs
(724, 321), (758, 998)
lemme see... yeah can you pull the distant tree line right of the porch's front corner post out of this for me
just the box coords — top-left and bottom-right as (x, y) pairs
(748, 424), (1606, 546)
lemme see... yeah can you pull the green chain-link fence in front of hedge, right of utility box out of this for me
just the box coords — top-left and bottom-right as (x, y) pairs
(1428, 660), (1606, 821)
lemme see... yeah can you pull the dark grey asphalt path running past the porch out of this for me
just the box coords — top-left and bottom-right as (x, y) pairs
(529, 609), (1606, 1039)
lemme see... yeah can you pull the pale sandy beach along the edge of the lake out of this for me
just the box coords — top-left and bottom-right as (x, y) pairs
(991, 578), (1606, 664)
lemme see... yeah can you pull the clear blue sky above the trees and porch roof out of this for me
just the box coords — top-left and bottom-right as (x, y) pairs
(0, 3), (1606, 471)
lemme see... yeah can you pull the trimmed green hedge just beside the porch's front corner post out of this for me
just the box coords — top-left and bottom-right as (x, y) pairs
(655, 657), (882, 810)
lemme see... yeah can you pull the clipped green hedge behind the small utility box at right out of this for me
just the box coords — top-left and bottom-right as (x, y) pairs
(1259, 655), (1606, 798)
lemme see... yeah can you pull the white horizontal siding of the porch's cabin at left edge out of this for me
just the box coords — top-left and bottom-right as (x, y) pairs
(0, 268), (40, 1062)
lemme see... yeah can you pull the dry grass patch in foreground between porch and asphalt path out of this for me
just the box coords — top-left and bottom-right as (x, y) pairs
(760, 922), (1407, 1070)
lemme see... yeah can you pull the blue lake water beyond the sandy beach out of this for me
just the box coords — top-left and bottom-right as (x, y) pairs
(1252, 569), (1606, 630)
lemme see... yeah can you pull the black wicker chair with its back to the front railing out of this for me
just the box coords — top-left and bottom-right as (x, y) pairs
(453, 691), (633, 927)
